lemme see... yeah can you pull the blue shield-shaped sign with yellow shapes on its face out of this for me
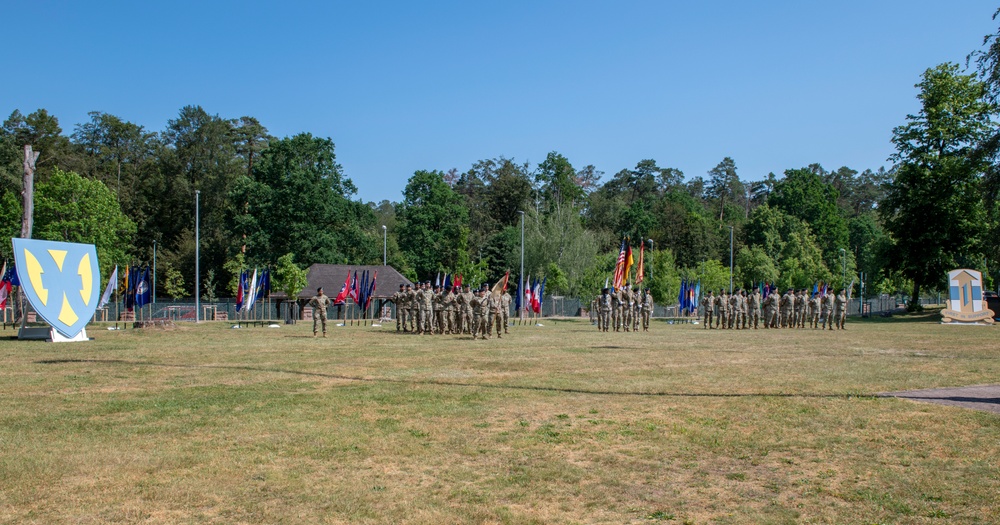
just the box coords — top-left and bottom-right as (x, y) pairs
(11, 239), (101, 338)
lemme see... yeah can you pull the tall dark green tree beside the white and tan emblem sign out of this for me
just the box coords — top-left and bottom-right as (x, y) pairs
(879, 63), (996, 307)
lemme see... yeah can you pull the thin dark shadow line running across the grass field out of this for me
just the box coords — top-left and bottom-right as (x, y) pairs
(35, 359), (879, 400)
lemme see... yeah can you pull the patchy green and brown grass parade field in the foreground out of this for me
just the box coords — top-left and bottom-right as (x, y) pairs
(0, 315), (1000, 524)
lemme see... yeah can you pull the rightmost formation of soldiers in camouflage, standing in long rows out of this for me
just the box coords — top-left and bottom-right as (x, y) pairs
(701, 288), (847, 330)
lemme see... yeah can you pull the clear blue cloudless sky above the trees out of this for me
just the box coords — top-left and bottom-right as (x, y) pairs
(0, 0), (997, 201)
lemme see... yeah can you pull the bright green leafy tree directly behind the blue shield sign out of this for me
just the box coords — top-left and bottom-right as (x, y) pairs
(32, 168), (135, 275)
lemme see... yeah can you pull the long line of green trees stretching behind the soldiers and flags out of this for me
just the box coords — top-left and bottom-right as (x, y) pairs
(0, 13), (1000, 308)
